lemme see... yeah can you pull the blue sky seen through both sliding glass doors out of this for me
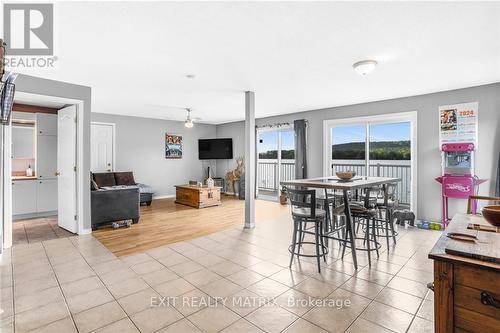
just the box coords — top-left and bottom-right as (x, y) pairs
(257, 122), (411, 153)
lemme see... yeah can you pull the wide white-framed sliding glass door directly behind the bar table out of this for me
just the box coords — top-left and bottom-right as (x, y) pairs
(325, 113), (416, 208)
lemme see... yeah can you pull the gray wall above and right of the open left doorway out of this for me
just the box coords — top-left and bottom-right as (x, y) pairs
(16, 74), (91, 229)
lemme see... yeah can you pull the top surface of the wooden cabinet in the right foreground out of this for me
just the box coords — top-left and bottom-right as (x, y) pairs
(429, 214), (500, 272)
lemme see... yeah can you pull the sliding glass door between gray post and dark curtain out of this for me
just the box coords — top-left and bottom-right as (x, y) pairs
(256, 127), (295, 200)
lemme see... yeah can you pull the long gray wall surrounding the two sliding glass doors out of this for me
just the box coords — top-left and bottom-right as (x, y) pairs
(217, 83), (500, 220)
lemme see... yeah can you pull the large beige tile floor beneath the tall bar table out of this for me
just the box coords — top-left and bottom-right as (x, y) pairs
(0, 209), (440, 333)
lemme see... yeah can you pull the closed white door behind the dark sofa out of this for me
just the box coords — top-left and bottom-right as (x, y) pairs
(90, 123), (114, 172)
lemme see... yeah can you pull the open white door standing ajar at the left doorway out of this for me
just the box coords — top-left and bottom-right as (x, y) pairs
(57, 105), (78, 233)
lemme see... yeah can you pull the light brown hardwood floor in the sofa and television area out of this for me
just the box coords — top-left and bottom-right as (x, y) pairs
(92, 196), (289, 256)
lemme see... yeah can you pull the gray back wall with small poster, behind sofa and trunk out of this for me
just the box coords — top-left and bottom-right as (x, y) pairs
(92, 113), (216, 197)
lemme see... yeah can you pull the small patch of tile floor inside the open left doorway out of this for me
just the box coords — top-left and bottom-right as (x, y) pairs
(12, 216), (73, 245)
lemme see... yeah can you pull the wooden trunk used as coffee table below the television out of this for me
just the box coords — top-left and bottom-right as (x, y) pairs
(175, 185), (221, 208)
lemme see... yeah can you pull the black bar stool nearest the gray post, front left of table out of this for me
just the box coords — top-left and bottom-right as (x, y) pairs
(287, 188), (328, 273)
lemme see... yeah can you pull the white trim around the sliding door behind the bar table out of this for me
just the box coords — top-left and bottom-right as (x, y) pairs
(323, 111), (418, 214)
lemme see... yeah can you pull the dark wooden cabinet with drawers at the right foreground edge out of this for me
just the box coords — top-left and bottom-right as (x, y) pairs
(429, 214), (500, 333)
